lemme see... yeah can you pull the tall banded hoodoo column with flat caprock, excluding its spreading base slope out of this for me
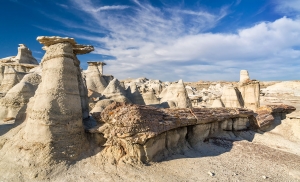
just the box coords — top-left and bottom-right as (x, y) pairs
(24, 37), (93, 160)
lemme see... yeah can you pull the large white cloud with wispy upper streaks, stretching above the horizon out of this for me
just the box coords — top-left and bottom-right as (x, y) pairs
(40, 0), (300, 81)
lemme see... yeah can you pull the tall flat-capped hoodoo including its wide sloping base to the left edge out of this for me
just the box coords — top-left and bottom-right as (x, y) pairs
(0, 37), (93, 179)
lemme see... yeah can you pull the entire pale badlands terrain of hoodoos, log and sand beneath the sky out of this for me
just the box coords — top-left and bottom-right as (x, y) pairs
(0, 36), (300, 181)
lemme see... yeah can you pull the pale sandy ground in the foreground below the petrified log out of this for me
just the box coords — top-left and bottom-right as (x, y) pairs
(52, 130), (300, 182)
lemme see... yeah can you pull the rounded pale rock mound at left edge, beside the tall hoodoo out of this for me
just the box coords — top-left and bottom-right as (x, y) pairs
(0, 73), (41, 120)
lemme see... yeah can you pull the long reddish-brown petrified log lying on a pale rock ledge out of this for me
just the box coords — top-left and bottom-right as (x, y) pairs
(91, 103), (254, 144)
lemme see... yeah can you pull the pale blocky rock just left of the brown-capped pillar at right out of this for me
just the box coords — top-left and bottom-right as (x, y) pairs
(221, 86), (243, 108)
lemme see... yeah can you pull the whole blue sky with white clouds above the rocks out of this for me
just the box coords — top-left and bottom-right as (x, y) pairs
(0, 0), (300, 81)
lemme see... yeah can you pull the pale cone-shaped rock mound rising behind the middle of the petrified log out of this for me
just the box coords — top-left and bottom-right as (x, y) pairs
(160, 80), (192, 108)
